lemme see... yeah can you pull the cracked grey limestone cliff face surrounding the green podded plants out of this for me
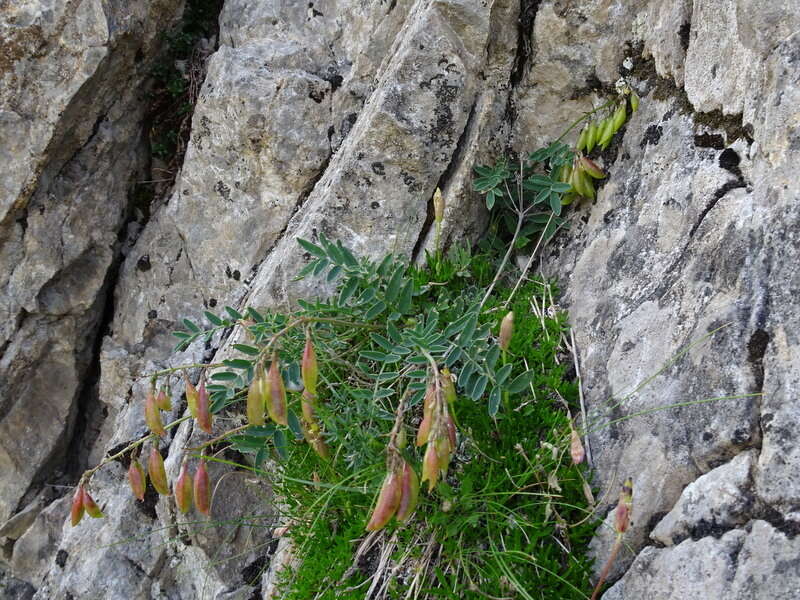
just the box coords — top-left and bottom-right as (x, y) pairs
(0, 0), (800, 599)
